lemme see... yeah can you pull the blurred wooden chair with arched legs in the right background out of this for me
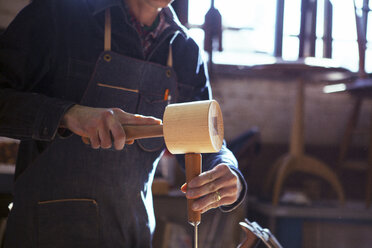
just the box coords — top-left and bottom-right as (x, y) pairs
(258, 58), (349, 205)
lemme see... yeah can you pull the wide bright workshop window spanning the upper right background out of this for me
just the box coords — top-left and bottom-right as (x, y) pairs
(188, 0), (372, 72)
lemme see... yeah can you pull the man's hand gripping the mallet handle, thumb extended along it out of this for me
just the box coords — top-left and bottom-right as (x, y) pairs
(61, 105), (161, 150)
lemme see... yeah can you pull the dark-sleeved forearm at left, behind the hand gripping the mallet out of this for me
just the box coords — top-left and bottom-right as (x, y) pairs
(0, 88), (74, 141)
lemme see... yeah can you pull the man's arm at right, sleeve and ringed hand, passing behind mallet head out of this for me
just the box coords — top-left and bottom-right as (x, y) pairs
(173, 36), (247, 212)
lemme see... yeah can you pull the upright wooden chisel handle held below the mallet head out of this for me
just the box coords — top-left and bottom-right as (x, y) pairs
(185, 153), (202, 226)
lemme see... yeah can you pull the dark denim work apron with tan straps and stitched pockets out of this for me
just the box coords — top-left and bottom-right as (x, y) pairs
(5, 10), (177, 248)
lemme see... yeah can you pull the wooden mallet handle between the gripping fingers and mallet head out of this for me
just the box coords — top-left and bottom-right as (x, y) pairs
(123, 125), (163, 140)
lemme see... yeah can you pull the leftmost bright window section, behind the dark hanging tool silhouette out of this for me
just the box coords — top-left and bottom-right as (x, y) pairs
(188, 0), (276, 64)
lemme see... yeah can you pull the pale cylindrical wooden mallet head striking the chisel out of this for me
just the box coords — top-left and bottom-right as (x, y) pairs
(163, 100), (224, 154)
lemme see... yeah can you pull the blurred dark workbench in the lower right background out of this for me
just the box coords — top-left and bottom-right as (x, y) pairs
(247, 198), (372, 248)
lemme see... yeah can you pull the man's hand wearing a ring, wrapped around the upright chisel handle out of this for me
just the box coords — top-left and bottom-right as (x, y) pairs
(181, 164), (242, 213)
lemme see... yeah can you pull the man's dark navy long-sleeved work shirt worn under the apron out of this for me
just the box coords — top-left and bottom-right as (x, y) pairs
(0, 0), (246, 211)
